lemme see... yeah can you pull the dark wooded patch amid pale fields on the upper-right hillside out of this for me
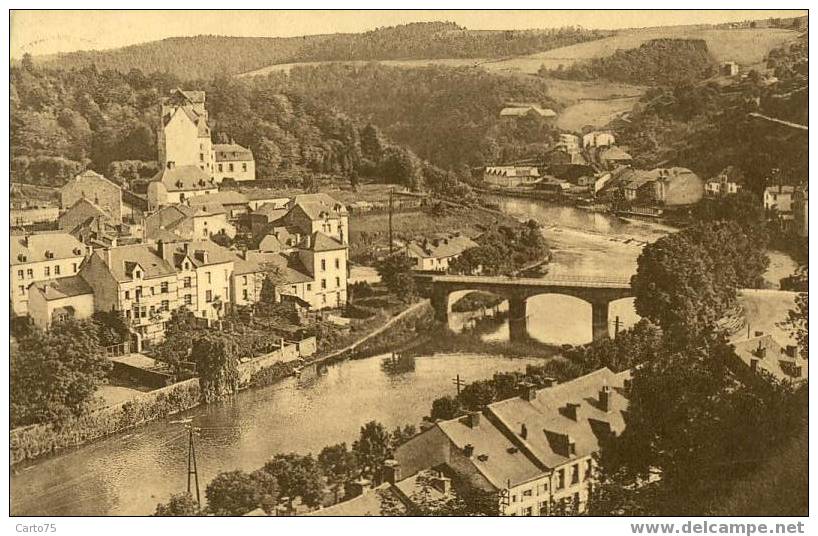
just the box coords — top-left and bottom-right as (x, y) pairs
(548, 39), (715, 86)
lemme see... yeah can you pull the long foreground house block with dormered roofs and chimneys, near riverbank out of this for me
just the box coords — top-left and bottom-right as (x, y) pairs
(394, 368), (630, 516)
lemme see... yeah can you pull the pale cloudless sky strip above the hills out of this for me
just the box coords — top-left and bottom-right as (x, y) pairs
(10, 10), (806, 58)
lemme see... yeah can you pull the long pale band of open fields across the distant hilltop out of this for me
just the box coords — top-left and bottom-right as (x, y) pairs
(237, 26), (798, 77)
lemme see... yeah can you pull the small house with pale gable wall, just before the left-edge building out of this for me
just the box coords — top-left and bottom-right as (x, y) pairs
(28, 275), (94, 330)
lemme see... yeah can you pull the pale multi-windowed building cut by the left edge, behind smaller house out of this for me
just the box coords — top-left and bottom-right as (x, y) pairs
(9, 232), (89, 316)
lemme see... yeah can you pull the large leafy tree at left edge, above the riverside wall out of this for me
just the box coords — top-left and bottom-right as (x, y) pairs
(10, 320), (111, 426)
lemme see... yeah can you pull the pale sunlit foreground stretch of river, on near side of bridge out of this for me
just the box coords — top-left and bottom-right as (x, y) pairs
(11, 354), (538, 515)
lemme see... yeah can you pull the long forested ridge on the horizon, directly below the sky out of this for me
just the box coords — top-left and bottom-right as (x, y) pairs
(28, 22), (610, 80)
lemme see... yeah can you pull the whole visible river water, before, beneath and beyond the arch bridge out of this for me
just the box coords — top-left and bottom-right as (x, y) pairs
(11, 198), (772, 515)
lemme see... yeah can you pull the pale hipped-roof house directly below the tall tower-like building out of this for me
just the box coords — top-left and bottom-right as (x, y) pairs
(148, 161), (219, 211)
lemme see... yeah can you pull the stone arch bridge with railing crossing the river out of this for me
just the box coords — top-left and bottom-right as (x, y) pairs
(431, 275), (633, 340)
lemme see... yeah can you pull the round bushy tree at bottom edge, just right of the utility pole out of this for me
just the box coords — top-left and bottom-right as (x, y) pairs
(205, 470), (277, 516)
